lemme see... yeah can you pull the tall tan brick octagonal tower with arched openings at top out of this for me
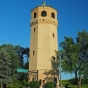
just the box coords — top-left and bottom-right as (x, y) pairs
(29, 2), (58, 84)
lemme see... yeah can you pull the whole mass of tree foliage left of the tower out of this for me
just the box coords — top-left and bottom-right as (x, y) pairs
(0, 44), (29, 85)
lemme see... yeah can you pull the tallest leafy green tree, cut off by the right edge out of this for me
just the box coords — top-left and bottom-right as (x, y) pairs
(76, 30), (88, 86)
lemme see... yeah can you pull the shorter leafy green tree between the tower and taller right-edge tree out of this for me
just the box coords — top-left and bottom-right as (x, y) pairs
(61, 37), (79, 82)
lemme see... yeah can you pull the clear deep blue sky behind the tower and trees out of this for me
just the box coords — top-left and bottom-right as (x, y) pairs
(0, 0), (88, 79)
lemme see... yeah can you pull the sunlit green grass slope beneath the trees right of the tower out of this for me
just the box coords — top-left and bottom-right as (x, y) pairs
(62, 80), (88, 88)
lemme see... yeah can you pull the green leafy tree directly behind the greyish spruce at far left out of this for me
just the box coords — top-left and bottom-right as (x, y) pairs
(0, 44), (22, 82)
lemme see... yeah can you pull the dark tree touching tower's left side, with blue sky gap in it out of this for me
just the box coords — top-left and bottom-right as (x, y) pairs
(16, 46), (30, 81)
